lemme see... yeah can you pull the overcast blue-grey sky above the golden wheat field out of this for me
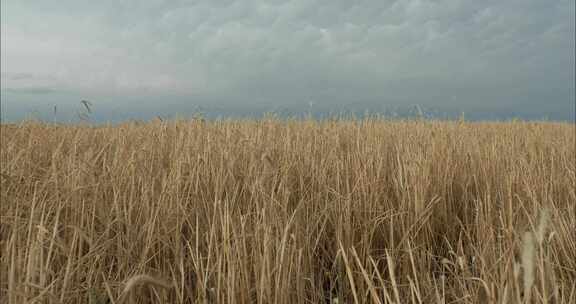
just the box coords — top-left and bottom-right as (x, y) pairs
(1, 0), (575, 120)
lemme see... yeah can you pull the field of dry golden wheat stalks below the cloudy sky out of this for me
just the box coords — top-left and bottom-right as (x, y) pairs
(0, 118), (576, 304)
